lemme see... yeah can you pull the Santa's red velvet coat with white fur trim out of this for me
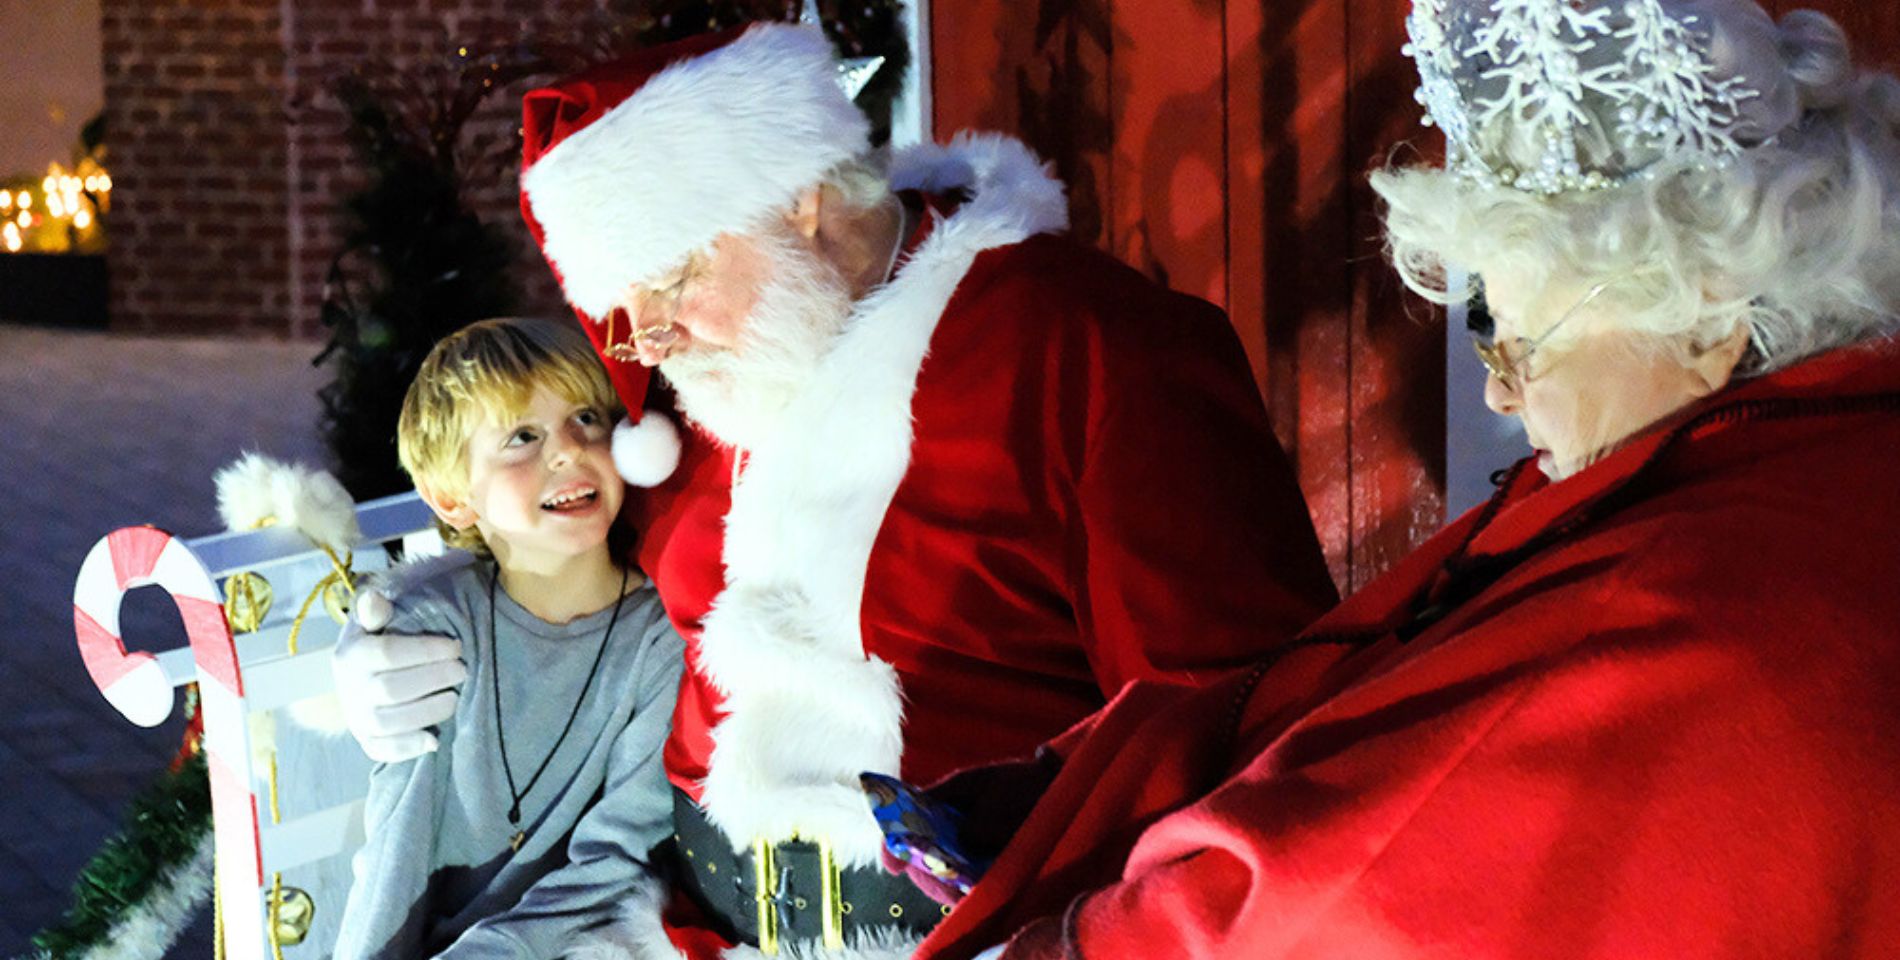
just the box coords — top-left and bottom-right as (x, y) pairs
(604, 139), (1334, 863)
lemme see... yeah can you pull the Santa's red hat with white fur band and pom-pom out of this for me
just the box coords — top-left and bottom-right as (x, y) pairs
(521, 23), (870, 485)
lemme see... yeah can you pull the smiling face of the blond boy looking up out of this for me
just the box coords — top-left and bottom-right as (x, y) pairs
(435, 386), (625, 572)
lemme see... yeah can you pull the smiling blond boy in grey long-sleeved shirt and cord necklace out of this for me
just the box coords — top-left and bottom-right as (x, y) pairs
(336, 319), (682, 960)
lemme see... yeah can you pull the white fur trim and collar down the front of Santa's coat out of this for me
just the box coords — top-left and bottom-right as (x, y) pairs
(699, 135), (1066, 867)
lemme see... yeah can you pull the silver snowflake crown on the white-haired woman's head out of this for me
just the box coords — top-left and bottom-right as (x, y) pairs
(1406, 0), (1758, 196)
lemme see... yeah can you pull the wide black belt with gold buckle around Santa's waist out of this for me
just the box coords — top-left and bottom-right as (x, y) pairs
(671, 789), (950, 954)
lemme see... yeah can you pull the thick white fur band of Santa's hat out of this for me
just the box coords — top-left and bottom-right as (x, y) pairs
(521, 23), (870, 319)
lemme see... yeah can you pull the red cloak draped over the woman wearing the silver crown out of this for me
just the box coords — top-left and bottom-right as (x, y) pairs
(920, 344), (1900, 960)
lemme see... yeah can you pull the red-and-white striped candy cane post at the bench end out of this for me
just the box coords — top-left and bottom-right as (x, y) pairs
(72, 527), (266, 960)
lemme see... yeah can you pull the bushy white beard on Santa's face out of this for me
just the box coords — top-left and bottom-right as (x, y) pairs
(659, 232), (851, 451)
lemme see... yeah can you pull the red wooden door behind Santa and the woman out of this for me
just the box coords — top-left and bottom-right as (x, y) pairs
(931, 0), (1900, 589)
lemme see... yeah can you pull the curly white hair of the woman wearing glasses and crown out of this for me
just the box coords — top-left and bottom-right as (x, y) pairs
(1372, 11), (1900, 374)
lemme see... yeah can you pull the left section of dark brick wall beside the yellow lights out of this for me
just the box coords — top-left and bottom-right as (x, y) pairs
(101, 0), (291, 335)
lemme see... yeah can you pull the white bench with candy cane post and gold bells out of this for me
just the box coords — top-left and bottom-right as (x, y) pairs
(72, 494), (441, 960)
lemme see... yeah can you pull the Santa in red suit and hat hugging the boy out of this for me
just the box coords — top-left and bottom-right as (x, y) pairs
(338, 25), (1334, 954)
